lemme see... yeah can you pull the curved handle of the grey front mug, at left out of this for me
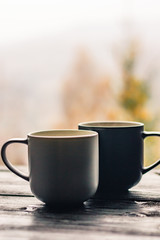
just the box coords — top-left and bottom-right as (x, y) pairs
(1, 138), (29, 181)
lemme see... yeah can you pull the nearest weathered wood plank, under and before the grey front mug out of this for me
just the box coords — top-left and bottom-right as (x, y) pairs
(0, 196), (160, 239)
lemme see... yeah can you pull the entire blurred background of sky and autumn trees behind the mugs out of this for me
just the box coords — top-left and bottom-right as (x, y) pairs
(0, 0), (160, 166)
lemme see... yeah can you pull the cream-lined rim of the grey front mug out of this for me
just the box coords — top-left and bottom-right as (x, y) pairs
(27, 129), (98, 139)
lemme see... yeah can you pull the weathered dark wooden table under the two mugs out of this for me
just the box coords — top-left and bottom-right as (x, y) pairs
(0, 167), (160, 240)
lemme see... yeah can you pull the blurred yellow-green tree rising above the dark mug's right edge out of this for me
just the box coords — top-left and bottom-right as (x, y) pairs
(119, 42), (153, 126)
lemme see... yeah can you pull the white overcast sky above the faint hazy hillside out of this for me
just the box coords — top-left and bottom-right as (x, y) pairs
(0, 0), (160, 45)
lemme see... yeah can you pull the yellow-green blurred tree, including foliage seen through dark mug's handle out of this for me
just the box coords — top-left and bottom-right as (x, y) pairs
(118, 41), (160, 165)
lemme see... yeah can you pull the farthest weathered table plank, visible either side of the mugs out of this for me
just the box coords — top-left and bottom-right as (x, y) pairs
(0, 167), (160, 201)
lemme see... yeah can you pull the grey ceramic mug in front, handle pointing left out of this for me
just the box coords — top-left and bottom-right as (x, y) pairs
(1, 130), (98, 206)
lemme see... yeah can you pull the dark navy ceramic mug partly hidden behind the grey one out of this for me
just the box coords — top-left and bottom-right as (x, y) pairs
(78, 121), (160, 195)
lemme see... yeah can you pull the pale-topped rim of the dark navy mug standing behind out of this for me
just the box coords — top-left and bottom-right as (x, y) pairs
(78, 121), (144, 129)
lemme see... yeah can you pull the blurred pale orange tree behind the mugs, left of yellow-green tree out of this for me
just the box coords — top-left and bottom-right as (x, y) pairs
(58, 47), (116, 128)
